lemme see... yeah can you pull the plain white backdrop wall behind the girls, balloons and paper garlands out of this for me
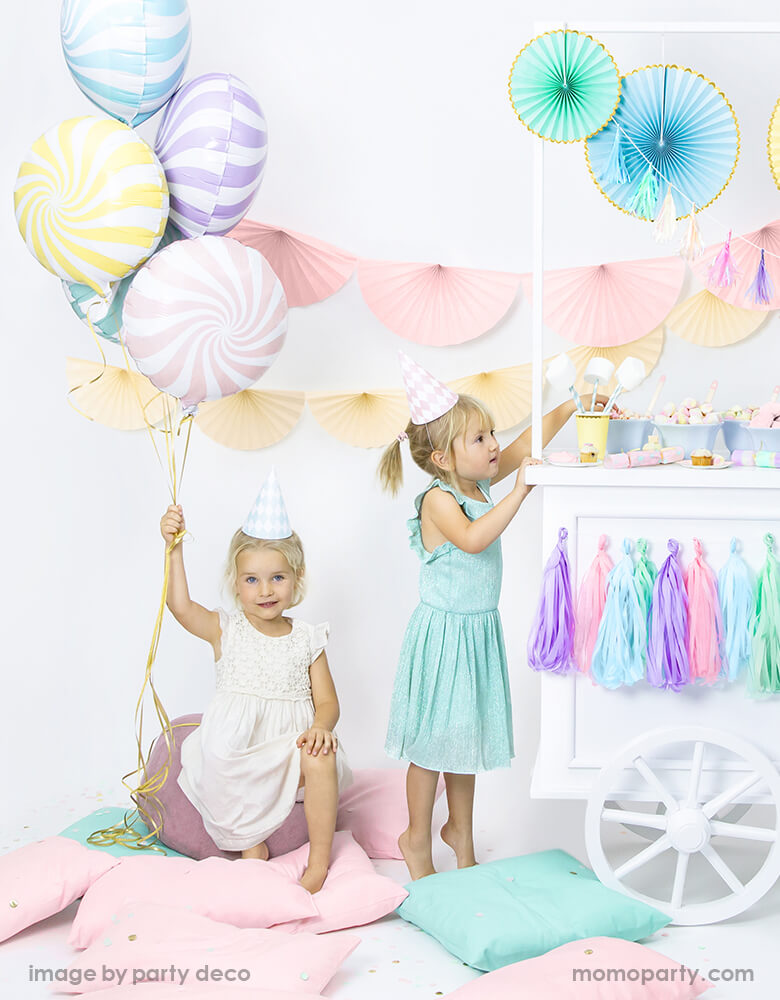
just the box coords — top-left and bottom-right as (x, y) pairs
(0, 0), (780, 854)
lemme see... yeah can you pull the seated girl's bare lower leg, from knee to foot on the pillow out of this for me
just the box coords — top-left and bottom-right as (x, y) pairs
(301, 747), (339, 892)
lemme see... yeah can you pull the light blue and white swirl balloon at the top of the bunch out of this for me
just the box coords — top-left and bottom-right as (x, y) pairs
(60, 0), (191, 125)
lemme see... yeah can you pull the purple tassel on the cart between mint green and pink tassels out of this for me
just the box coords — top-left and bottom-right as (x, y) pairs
(647, 538), (691, 691)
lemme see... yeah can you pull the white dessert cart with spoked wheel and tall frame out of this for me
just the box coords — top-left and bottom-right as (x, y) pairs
(528, 15), (780, 924)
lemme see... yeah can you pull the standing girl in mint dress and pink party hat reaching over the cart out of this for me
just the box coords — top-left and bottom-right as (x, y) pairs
(379, 353), (588, 879)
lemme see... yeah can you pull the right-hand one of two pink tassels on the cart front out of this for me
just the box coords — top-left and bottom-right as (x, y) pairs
(685, 538), (725, 684)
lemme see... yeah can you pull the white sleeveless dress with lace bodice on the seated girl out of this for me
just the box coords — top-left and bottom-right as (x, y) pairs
(179, 609), (352, 851)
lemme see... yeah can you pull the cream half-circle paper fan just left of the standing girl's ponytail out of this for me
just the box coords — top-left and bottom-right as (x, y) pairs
(306, 389), (409, 448)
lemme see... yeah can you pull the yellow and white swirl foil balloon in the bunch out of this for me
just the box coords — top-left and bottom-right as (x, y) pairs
(14, 115), (168, 295)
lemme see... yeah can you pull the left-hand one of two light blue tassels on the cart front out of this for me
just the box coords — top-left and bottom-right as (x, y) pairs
(590, 538), (647, 688)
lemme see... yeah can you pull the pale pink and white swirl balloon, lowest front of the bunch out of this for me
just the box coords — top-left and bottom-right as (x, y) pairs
(123, 236), (287, 413)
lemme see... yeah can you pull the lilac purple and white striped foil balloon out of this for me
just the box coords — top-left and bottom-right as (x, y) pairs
(154, 73), (268, 236)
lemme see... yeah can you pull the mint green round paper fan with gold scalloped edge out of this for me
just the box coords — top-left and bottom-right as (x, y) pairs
(509, 31), (621, 142)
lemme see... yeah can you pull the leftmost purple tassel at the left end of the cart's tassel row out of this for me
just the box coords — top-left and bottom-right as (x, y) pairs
(528, 528), (574, 674)
